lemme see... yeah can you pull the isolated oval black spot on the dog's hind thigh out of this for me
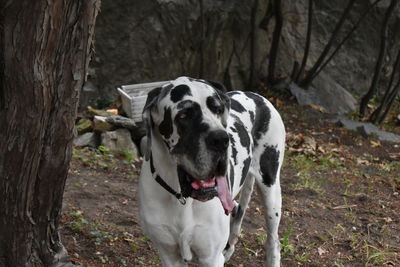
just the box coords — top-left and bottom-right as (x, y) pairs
(260, 146), (279, 186)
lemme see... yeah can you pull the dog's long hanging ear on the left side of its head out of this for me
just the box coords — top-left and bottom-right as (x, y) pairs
(142, 87), (161, 160)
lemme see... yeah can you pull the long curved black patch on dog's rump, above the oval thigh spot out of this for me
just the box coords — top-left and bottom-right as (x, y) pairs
(245, 92), (271, 145)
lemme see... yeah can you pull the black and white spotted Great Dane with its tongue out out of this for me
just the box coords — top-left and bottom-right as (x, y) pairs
(138, 77), (285, 267)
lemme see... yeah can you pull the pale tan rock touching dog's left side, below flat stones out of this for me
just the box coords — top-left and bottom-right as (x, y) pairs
(101, 128), (139, 161)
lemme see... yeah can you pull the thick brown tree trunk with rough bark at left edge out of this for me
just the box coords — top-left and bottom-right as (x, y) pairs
(0, 0), (100, 267)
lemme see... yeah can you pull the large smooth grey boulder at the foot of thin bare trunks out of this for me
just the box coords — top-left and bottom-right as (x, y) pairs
(289, 73), (357, 115)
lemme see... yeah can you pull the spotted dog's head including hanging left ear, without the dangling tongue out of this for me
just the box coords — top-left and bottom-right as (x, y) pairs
(143, 77), (230, 207)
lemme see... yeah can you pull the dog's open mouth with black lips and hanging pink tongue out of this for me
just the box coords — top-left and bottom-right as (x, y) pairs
(178, 161), (235, 215)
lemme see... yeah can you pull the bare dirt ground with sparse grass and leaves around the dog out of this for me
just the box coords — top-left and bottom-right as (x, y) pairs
(62, 99), (400, 267)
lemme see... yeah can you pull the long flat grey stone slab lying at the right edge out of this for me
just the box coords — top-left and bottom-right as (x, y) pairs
(335, 118), (400, 143)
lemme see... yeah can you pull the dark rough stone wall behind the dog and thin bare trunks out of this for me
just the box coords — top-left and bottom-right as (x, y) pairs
(83, 0), (399, 107)
